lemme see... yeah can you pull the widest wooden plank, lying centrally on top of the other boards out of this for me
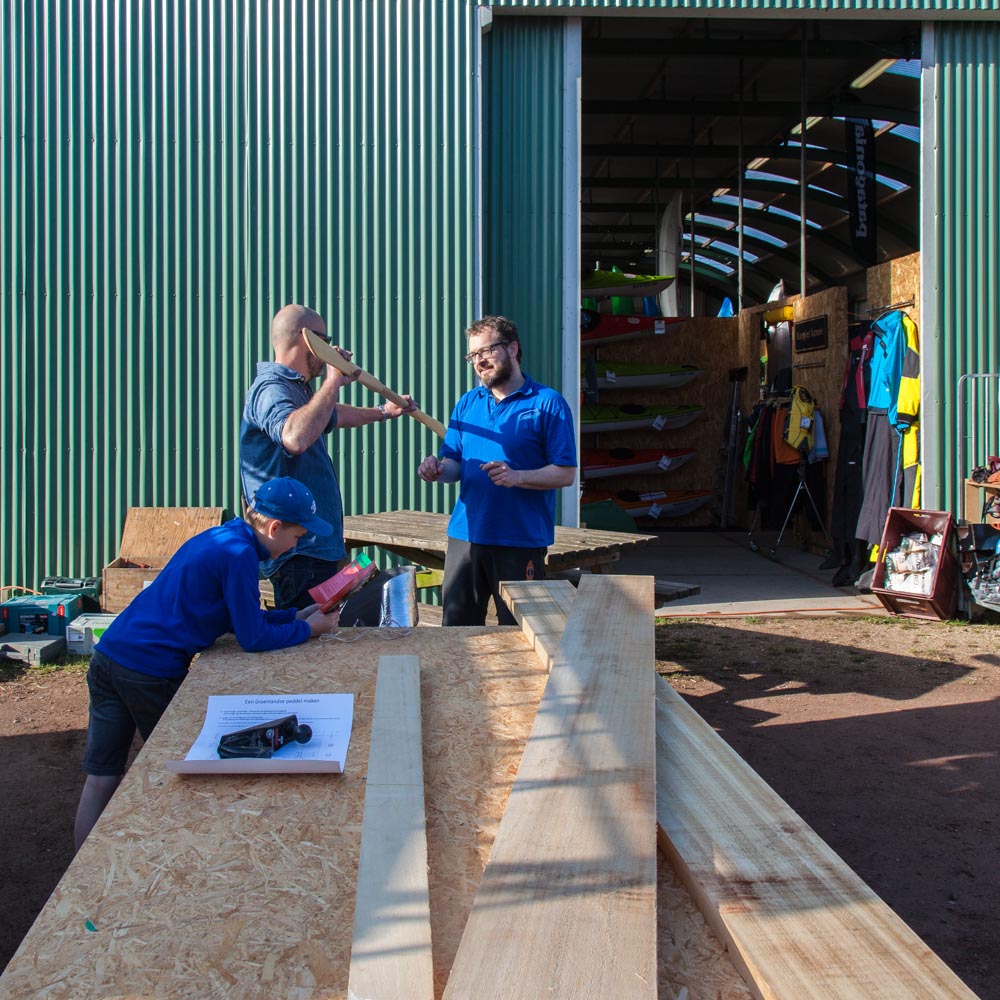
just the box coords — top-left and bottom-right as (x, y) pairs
(445, 576), (657, 1000)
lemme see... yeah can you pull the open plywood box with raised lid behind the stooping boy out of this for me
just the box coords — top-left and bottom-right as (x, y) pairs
(101, 507), (228, 614)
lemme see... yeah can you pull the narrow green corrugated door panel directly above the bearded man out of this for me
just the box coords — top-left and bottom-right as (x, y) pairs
(483, 18), (564, 387)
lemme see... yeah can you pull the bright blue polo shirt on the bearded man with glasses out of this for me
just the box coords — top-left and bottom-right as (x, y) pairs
(441, 375), (576, 549)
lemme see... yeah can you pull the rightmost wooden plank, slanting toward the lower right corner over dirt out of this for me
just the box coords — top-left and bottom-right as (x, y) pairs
(656, 677), (975, 1000)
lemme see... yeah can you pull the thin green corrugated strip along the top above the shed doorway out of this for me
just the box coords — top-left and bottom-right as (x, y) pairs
(483, 0), (1000, 11)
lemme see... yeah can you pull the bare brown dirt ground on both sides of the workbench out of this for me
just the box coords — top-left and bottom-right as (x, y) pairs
(0, 618), (1000, 1000)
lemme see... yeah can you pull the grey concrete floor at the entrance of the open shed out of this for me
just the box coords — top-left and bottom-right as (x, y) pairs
(614, 531), (887, 616)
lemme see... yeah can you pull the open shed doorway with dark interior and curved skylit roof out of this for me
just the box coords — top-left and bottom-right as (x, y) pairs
(580, 15), (921, 568)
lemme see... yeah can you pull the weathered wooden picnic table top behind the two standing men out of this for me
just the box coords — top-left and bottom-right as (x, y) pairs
(344, 510), (658, 573)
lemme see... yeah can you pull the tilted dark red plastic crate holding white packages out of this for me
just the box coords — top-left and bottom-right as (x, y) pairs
(872, 507), (961, 621)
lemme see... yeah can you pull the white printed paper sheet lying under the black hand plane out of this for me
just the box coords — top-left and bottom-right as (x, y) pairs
(166, 694), (354, 774)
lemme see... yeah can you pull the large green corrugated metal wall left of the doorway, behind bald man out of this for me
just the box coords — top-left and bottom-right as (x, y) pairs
(0, 0), (478, 586)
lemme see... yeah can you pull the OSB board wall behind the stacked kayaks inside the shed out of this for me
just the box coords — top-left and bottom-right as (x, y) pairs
(582, 317), (745, 531)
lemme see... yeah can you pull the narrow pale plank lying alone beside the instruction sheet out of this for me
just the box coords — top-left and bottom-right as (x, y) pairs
(348, 656), (434, 1000)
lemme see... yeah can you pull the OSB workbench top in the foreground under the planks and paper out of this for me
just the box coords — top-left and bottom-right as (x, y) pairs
(0, 619), (749, 1000)
